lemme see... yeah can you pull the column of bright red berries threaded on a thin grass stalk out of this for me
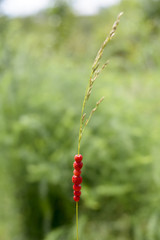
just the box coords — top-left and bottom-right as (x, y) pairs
(72, 154), (83, 202)
